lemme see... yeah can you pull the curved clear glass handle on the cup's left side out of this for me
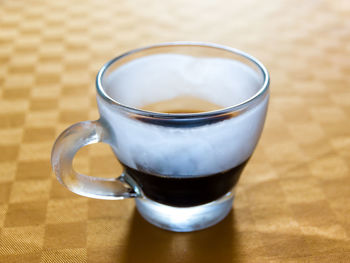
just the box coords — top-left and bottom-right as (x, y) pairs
(51, 120), (140, 200)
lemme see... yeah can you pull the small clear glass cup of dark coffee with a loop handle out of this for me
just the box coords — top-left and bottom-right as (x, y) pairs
(53, 43), (269, 232)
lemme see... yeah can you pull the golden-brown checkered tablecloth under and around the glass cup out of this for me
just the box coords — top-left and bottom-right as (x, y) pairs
(0, 0), (350, 263)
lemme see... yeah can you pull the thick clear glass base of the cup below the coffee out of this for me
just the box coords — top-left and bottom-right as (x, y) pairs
(136, 192), (234, 232)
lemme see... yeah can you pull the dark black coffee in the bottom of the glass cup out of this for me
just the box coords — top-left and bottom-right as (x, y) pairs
(123, 161), (247, 207)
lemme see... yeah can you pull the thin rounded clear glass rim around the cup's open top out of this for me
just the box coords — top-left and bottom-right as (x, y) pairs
(96, 41), (270, 119)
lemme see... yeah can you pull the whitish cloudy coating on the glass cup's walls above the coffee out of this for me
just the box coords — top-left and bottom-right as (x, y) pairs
(97, 54), (268, 177)
